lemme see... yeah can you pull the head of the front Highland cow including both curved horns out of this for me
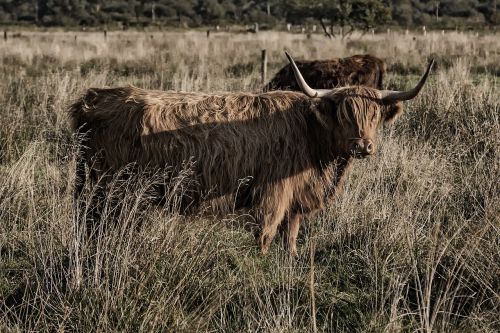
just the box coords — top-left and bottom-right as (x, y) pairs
(285, 52), (434, 158)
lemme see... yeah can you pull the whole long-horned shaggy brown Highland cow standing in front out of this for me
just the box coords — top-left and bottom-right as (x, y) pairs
(70, 54), (433, 253)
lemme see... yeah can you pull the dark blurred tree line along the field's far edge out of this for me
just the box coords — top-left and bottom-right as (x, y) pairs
(0, 0), (500, 29)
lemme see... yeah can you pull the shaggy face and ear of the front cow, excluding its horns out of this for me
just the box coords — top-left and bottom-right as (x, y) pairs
(322, 87), (402, 158)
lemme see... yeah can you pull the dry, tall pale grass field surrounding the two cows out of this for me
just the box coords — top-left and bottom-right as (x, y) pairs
(0, 31), (500, 332)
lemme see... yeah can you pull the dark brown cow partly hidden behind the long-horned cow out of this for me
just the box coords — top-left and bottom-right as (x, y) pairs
(264, 54), (386, 91)
